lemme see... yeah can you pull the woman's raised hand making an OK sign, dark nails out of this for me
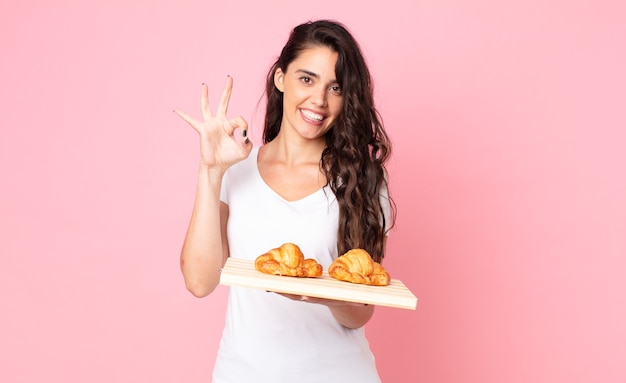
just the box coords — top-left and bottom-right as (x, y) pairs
(174, 76), (252, 172)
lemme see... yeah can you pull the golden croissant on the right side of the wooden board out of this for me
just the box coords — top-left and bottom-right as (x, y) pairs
(328, 249), (391, 286)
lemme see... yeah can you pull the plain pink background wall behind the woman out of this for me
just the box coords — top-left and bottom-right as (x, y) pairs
(0, 0), (626, 383)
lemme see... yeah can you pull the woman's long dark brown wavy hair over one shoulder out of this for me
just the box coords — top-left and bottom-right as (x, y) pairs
(263, 20), (395, 262)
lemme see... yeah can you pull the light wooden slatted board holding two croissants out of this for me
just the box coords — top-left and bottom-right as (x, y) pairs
(220, 258), (417, 310)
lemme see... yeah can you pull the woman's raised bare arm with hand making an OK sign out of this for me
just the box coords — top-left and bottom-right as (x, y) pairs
(174, 76), (252, 297)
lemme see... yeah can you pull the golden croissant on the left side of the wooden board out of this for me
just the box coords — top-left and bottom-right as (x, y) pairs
(254, 243), (322, 278)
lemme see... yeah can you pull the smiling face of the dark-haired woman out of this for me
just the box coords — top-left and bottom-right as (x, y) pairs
(274, 46), (343, 139)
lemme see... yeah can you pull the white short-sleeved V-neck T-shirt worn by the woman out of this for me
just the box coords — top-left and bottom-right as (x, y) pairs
(213, 147), (380, 383)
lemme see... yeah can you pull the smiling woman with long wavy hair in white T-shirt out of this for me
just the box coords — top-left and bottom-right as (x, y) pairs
(176, 20), (394, 383)
